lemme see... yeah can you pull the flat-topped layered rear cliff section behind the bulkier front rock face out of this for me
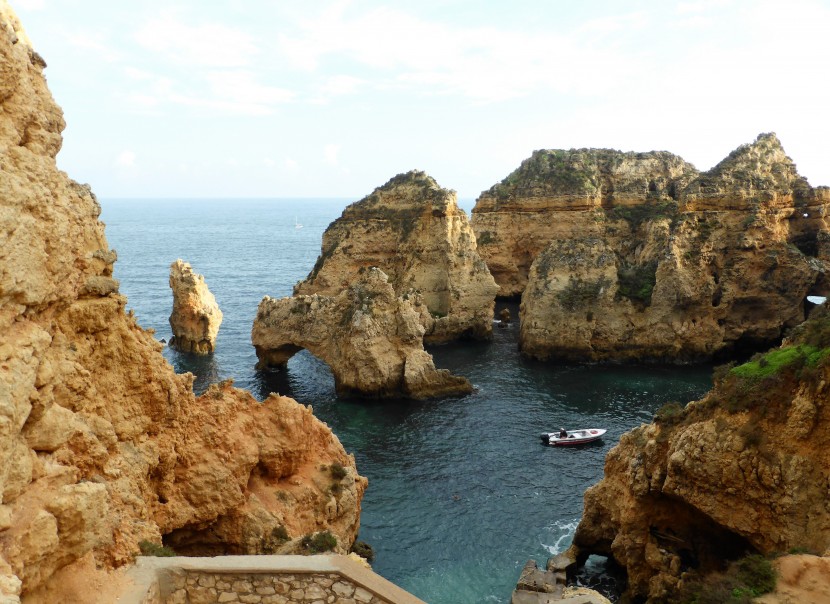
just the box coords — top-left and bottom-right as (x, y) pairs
(472, 149), (697, 297)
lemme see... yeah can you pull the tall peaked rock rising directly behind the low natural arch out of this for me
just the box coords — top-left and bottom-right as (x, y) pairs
(294, 171), (497, 342)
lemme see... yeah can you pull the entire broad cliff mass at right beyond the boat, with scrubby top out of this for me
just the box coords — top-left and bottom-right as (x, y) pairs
(473, 134), (830, 362)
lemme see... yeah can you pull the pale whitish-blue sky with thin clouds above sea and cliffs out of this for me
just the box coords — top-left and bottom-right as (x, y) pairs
(9, 0), (830, 199)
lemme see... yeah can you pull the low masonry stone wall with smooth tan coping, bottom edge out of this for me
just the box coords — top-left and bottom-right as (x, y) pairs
(118, 555), (424, 604)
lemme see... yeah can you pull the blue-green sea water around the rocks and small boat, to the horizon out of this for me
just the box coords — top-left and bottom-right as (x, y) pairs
(101, 199), (711, 604)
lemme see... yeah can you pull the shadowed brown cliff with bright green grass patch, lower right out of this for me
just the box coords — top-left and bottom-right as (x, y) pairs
(574, 307), (830, 601)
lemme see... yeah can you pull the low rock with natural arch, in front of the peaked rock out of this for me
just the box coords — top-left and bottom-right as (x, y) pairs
(251, 267), (472, 399)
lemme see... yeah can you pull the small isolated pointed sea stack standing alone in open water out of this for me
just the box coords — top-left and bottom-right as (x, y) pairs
(170, 259), (222, 354)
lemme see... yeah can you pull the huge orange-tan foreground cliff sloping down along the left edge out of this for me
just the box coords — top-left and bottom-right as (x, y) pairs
(0, 0), (366, 600)
